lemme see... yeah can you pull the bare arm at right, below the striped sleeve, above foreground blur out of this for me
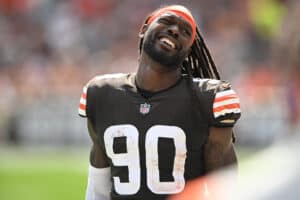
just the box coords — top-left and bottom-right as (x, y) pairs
(204, 127), (237, 173)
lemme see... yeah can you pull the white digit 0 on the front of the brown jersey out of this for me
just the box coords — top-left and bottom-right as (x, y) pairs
(145, 126), (186, 194)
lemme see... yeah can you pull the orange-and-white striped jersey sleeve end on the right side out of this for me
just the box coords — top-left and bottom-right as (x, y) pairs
(212, 87), (241, 127)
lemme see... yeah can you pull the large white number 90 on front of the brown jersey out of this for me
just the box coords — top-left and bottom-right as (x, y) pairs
(104, 125), (186, 195)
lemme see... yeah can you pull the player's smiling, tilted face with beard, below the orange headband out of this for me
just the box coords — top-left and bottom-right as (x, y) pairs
(140, 12), (193, 69)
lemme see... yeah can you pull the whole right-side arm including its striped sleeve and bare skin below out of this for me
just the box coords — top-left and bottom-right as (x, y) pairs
(199, 80), (241, 173)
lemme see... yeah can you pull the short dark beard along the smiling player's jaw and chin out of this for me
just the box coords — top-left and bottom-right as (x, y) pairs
(143, 35), (187, 70)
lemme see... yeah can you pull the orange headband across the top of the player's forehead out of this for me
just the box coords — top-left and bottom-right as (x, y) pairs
(147, 5), (196, 41)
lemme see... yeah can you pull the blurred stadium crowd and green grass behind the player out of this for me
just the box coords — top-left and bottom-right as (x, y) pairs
(0, 0), (300, 199)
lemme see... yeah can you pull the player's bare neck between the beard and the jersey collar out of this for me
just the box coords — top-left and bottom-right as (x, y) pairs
(136, 53), (181, 92)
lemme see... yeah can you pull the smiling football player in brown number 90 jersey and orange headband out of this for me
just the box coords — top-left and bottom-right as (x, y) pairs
(79, 5), (240, 200)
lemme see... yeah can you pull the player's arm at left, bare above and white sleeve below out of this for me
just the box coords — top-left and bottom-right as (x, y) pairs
(85, 120), (111, 200)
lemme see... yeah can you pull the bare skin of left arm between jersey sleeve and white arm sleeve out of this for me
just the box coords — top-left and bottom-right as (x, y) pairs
(87, 120), (109, 168)
